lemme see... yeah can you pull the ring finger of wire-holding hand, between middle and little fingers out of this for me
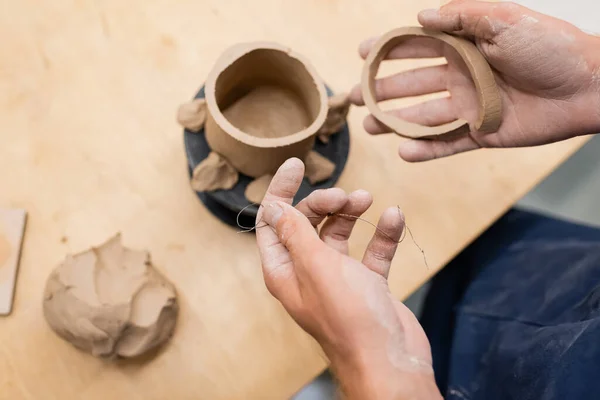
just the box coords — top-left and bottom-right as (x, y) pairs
(319, 190), (373, 254)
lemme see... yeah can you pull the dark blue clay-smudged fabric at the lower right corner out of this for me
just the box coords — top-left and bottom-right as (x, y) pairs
(421, 210), (600, 400)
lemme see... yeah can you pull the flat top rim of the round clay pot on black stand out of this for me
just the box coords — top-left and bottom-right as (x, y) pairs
(205, 42), (328, 148)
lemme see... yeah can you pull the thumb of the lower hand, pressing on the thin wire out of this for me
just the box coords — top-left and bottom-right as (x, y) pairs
(263, 201), (321, 261)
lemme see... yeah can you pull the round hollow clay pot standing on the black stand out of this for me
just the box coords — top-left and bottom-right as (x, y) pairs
(205, 42), (328, 178)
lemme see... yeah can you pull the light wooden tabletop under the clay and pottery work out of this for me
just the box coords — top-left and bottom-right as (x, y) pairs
(0, 0), (585, 400)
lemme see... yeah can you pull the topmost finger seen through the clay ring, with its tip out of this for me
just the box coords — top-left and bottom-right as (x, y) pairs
(358, 37), (444, 60)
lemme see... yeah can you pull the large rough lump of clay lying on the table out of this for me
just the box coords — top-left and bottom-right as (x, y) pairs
(44, 235), (179, 358)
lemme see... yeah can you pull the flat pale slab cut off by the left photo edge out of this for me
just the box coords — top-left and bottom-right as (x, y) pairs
(0, 209), (27, 315)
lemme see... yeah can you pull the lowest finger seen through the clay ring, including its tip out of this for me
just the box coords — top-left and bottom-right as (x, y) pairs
(363, 97), (458, 135)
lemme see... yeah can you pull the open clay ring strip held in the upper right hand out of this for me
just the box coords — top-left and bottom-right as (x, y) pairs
(361, 27), (502, 139)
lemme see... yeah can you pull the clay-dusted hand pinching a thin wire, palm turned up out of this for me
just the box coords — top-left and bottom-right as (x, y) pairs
(256, 159), (441, 399)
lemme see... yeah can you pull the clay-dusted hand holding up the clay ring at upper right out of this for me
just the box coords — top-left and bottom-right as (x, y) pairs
(351, 0), (600, 161)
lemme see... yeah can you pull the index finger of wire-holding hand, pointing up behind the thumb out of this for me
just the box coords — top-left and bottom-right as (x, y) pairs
(256, 158), (304, 305)
